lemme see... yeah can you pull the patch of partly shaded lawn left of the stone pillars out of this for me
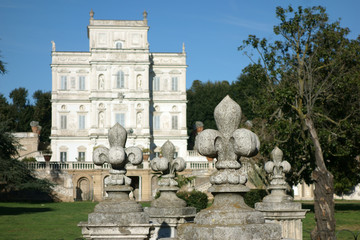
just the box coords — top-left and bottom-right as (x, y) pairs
(0, 202), (96, 240)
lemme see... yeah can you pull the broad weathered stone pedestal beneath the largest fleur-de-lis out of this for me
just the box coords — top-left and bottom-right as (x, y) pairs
(178, 185), (281, 240)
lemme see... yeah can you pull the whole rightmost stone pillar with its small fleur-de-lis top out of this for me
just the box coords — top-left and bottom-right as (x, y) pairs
(255, 147), (308, 240)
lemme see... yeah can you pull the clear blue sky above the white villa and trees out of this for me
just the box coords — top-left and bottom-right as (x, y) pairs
(0, 0), (360, 101)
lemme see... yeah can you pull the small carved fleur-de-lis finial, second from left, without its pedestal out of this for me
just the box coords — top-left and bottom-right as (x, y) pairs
(150, 140), (186, 186)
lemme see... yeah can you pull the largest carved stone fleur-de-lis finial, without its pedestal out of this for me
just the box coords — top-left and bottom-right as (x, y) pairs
(195, 96), (260, 191)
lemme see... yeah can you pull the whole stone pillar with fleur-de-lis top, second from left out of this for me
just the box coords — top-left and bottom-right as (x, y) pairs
(145, 140), (196, 240)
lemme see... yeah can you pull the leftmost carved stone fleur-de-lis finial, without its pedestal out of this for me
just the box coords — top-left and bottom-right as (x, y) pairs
(93, 123), (143, 189)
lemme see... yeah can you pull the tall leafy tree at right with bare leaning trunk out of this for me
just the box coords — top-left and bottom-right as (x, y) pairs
(239, 6), (360, 239)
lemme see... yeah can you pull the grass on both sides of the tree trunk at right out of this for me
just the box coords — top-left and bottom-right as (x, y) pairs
(302, 201), (360, 240)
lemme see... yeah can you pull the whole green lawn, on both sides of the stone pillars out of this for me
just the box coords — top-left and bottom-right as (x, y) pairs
(0, 201), (360, 240)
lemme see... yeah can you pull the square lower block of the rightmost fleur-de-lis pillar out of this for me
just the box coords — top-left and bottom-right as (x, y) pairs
(255, 202), (308, 240)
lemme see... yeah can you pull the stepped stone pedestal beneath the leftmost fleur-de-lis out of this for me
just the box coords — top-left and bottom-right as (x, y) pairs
(78, 186), (151, 239)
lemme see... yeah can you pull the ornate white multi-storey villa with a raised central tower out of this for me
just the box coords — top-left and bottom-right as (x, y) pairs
(51, 11), (188, 162)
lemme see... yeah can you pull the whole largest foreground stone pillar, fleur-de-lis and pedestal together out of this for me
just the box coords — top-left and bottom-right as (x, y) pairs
(178, 96), (281, 240)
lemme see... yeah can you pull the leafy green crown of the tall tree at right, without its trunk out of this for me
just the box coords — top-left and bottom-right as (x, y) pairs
(239, 7), (360, 194)
